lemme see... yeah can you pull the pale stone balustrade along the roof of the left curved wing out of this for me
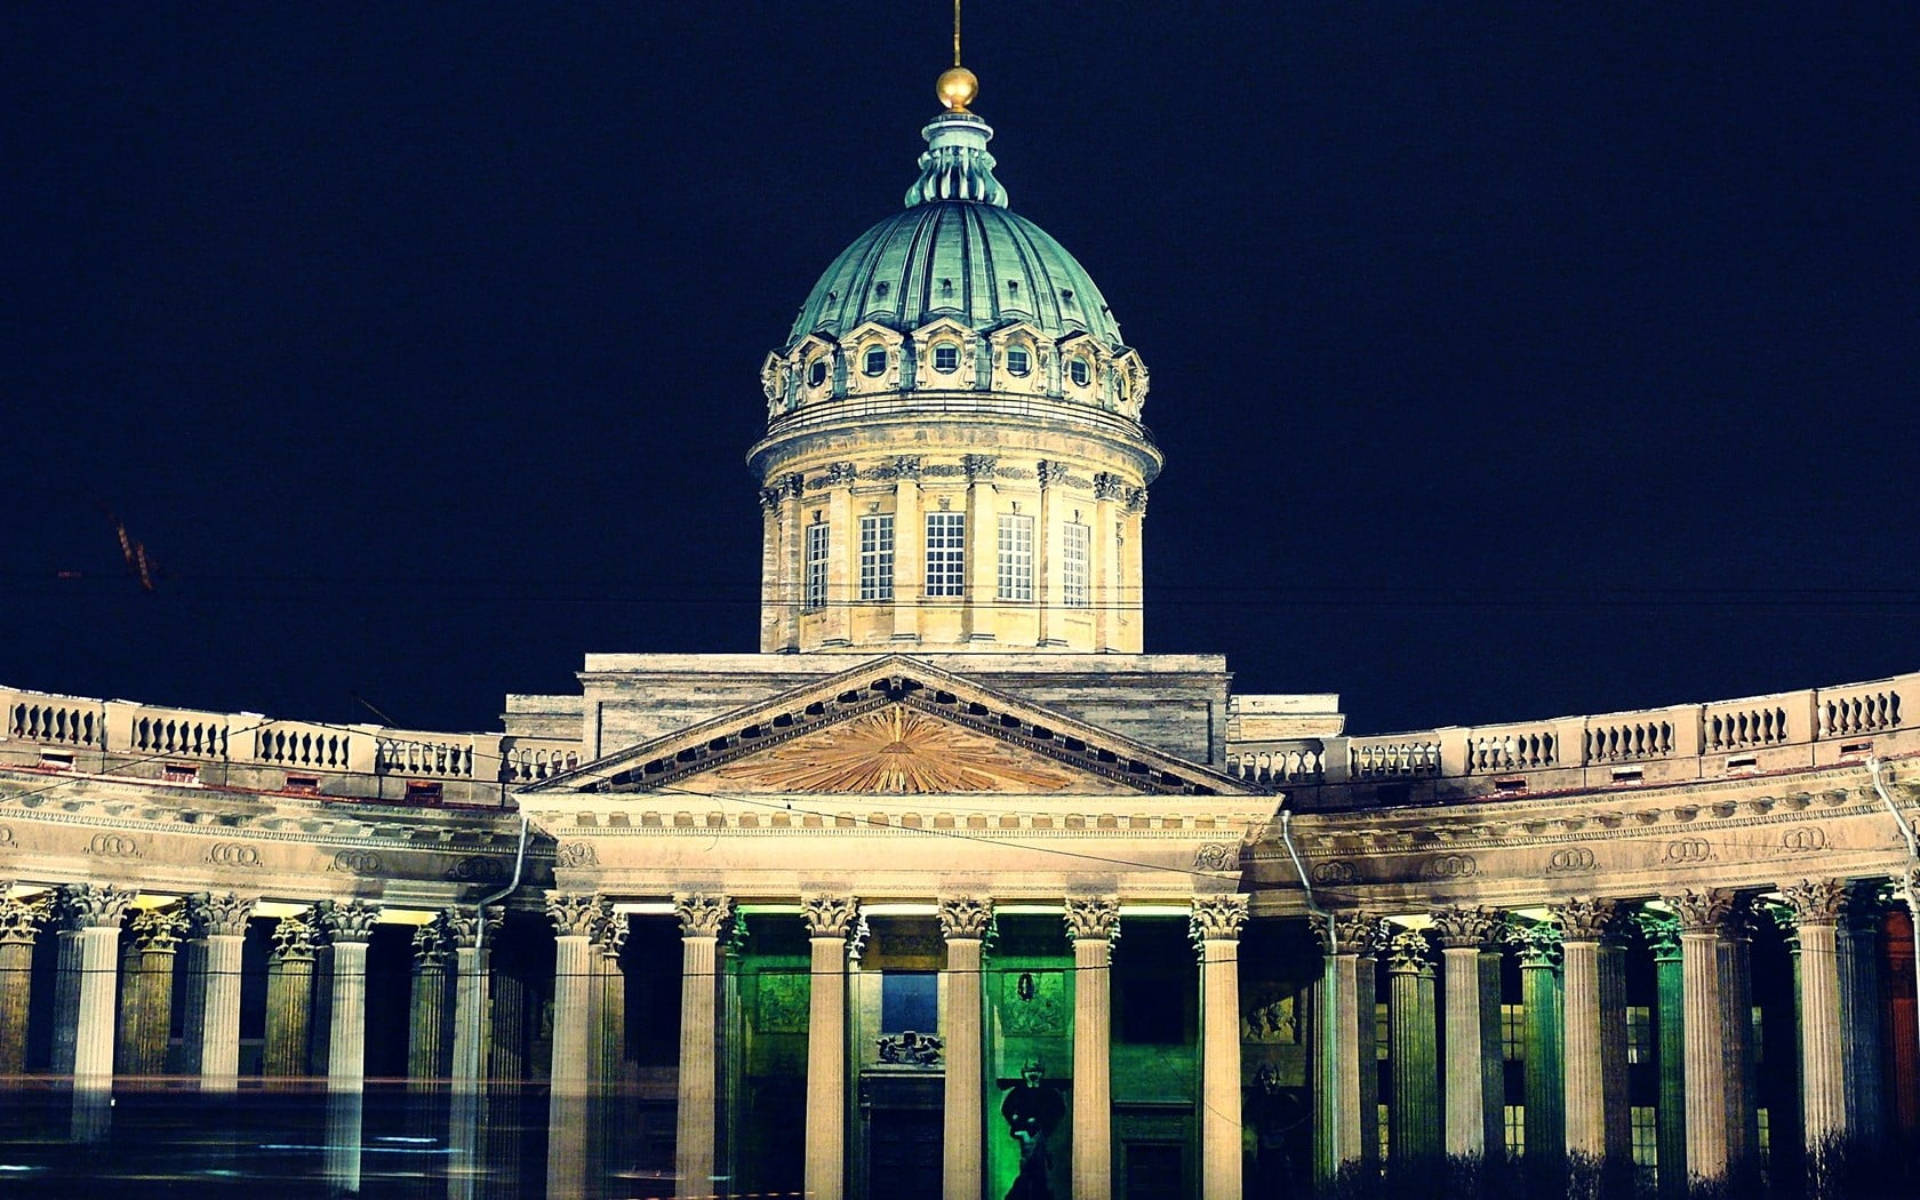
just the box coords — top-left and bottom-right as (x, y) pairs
(0, 689), (580, 803)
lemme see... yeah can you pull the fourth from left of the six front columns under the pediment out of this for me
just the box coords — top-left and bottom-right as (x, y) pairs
(939, 897), (993, 1200)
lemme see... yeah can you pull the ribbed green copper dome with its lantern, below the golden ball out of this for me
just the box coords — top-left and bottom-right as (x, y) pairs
(787, 113), (1123, 349)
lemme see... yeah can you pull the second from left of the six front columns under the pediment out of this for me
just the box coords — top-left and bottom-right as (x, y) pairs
(674, 893), (733, 1196)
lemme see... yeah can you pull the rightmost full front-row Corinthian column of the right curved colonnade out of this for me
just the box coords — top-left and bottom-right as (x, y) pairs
(1780, 879), (1847, 1169)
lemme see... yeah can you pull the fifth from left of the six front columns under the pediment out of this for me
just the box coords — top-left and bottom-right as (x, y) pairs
(1068, 897), (1119, 1200)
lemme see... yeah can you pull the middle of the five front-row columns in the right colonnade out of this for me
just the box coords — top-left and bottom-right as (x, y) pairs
(1549, 899), (1628, 1165)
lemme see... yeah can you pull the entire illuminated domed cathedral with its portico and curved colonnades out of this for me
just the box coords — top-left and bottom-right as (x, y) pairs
(0, 67), (1920, 1200)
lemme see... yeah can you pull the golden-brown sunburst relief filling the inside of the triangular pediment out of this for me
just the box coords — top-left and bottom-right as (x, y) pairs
(712, 705), (1104, 795)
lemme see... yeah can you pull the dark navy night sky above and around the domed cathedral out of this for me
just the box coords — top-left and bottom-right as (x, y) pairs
(0, 0), (1920, 732)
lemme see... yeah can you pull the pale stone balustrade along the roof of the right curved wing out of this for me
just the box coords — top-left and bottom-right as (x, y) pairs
(1227, 674), (1920, 806)
